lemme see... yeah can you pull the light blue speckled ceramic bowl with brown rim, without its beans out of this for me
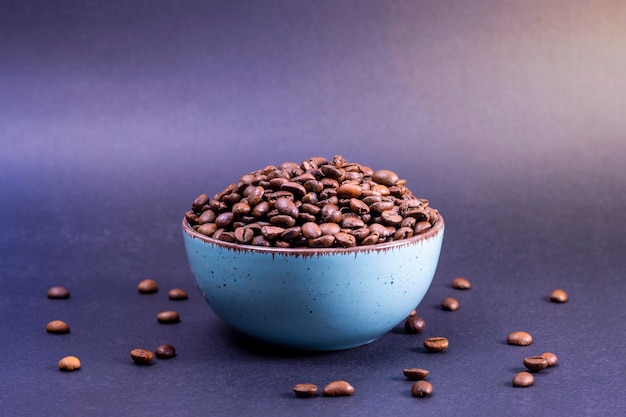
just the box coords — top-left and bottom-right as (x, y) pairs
(183, 216), (444, 351)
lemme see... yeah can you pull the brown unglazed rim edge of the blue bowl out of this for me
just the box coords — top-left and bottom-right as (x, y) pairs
(182, 213), (444, 257)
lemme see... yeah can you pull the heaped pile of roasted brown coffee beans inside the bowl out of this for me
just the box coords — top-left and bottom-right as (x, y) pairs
(185, 155), (439, 248)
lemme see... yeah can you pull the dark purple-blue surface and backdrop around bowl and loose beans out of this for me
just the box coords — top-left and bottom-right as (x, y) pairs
(0, 1), (626, 417)
